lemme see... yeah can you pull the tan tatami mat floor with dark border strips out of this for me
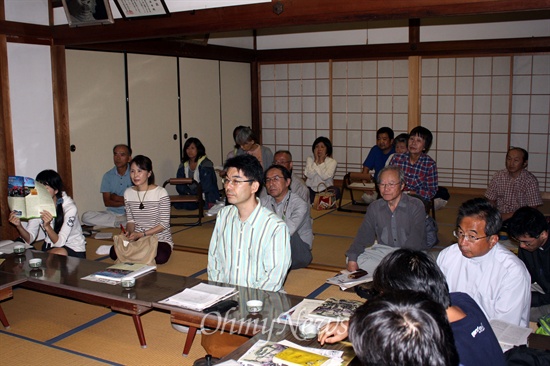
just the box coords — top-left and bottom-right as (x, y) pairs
(0, 195), (550, 365)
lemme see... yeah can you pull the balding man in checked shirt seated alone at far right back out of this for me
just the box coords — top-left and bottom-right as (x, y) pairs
(485, 147), (542, 222)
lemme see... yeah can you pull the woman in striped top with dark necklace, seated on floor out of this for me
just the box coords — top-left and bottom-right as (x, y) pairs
(109, 155), (174, 264)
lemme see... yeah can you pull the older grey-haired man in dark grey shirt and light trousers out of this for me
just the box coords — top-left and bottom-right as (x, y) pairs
(346, 166), (428, 274)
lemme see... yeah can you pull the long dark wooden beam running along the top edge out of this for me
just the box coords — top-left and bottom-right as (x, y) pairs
(52, 0), (550, 46)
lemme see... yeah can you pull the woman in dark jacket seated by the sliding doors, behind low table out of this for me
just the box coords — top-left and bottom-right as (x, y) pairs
(173, 137), (220, 210)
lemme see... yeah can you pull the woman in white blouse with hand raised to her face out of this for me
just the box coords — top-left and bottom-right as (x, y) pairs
(304, 136), (340, 203)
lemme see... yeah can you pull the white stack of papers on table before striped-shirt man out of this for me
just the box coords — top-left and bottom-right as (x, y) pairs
(159, 283), (237, 311)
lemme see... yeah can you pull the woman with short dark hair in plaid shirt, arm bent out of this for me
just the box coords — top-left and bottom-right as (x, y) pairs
(390, 126), (437, 201)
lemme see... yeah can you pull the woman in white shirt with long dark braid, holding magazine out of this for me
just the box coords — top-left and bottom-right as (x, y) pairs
(9, 170), (86, 258)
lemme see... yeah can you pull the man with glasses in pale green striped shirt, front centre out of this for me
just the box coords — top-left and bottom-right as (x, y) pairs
(208, 154), (290, 291)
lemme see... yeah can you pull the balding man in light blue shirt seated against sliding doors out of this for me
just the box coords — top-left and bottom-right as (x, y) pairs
(82, 144), (132, 227)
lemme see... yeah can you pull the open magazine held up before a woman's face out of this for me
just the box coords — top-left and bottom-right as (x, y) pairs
(8, 176), (56, 219)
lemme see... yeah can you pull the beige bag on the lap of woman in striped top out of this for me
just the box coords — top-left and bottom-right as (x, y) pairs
(113, 235), (158, 266)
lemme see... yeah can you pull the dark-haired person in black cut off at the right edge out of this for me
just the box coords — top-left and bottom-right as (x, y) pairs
(508, 207), (550, 322)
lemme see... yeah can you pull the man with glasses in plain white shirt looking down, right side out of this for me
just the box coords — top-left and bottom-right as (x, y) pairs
(437, 198), (531, 327)
